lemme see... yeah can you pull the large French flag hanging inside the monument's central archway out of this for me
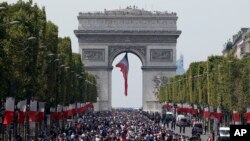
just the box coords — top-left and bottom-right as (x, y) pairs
(115, 53), (129, 96)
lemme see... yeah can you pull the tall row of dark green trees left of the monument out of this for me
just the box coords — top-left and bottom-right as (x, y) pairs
(0, 0), (97, 106)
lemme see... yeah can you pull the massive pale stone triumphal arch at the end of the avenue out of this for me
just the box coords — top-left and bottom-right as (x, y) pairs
(74, 8), (181, 111)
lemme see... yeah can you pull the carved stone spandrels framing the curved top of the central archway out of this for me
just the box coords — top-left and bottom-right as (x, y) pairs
(108, 46), (146, 66)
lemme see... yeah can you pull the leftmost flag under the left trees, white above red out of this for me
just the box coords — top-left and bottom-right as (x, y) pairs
(3, 97), (15, 124)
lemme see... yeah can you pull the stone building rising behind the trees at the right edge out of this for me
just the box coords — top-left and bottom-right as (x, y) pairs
(222, 28), (250, 59)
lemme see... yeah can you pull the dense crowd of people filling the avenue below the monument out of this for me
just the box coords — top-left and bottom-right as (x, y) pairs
(29, 110), (200, 141)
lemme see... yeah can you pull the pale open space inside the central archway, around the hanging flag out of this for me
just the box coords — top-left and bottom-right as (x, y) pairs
(111, 51), (143, 108)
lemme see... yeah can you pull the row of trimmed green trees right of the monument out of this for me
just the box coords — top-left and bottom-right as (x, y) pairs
(157, 56), (250, 113)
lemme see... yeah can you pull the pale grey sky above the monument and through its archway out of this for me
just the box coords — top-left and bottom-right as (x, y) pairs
(0, 0), (250, 107)
